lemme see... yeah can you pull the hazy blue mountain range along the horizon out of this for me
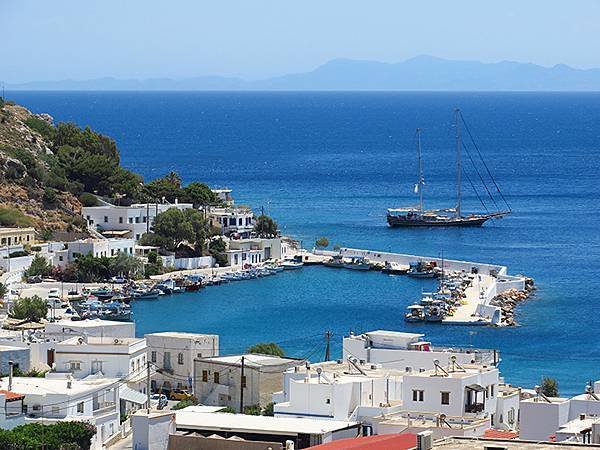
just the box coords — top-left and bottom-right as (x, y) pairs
(6, 56), (600, 91)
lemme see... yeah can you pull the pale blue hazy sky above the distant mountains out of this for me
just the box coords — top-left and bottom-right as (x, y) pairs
(0, 0), (600, 82)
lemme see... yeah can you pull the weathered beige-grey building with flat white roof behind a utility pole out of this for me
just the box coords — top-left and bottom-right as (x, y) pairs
(194, 354), (304, 411)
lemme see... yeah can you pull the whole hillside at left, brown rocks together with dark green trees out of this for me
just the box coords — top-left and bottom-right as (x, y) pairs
(0, 99), (218, 234)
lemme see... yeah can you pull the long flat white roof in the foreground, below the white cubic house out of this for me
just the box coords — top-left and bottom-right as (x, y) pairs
(175, 408), (358, 435)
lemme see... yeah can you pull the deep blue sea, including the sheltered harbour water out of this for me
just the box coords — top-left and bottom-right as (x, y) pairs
(7, 92), (600, 394)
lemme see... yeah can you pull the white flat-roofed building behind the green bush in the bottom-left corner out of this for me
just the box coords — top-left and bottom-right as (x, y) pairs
(0, 373), (120, 449)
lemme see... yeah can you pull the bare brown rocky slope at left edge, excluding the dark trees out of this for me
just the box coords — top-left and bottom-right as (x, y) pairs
(0, 100), (85, 233)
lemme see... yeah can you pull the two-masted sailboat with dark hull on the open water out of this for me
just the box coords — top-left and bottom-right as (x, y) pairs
(387, 109), (511, 227)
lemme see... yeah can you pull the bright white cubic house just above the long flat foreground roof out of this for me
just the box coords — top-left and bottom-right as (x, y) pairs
(273, 360), (404, 422)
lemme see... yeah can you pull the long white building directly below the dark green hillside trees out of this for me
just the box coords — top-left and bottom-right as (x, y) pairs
(81, 201), (193, 241)
